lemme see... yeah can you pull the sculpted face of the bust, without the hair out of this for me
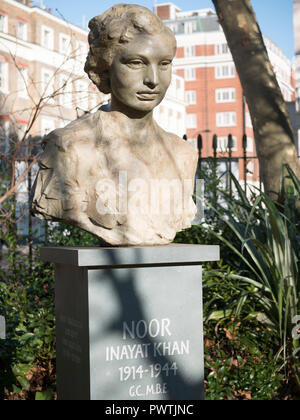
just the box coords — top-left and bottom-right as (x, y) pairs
(110, 33), (175, 113)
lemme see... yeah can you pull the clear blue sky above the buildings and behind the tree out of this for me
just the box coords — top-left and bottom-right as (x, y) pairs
(34, 0), (294, 59)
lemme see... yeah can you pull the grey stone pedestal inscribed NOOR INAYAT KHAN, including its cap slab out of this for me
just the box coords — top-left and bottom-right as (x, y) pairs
(41, 245), (219, 400)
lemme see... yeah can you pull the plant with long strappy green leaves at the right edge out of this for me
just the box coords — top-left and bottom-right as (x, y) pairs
(206, 167), (300, 387)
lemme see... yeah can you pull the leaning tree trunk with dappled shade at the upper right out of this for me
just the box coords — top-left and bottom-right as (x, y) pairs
(213, 0), (300, 200)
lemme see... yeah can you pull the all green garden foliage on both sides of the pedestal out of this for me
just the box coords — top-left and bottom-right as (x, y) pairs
(0, 163), (300, 400)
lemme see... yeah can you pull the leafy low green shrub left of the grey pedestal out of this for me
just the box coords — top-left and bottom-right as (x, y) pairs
(0, 251), (55, 397)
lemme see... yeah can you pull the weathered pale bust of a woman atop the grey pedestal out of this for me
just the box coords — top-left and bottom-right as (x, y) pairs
(32, 4), (197, 246)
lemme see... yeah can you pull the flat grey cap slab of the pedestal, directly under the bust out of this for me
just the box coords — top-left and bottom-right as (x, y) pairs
(40, 244), (220, 267)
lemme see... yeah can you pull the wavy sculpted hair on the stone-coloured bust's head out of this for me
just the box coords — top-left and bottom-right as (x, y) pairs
(84, 4), (176, 94)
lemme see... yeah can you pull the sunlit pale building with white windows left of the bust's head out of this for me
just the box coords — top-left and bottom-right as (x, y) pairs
(0, 0), (108, 136)
